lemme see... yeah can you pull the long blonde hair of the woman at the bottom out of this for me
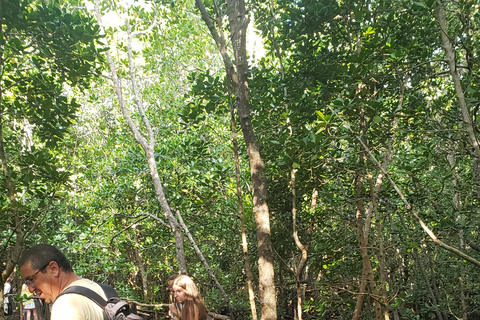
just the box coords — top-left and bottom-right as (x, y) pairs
(173, 275), (208, 320)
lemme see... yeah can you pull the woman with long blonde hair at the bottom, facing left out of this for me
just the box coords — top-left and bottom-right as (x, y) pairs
(172, 275), (207, 320)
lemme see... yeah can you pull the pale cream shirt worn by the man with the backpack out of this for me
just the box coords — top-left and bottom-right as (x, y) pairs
(50, 279), (107, 320)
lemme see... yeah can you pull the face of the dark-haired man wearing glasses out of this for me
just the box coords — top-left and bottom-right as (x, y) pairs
(20, 261), (58, 303)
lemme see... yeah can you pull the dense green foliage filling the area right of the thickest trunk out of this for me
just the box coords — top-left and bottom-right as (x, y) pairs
(249, 0), (478, 319)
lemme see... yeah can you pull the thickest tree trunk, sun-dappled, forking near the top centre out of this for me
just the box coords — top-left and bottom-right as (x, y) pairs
(196, 0), (277, 320)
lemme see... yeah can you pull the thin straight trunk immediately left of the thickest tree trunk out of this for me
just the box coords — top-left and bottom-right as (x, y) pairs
(230, 105), (257, 320)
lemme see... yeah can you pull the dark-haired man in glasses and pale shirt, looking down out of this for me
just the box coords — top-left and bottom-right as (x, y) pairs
(18, 244), (107, 320)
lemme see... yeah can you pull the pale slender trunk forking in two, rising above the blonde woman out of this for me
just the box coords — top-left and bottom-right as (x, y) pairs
(95, 0), (187, 273)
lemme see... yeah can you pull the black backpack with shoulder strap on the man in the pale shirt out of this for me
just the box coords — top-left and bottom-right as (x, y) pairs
(57, 283), (144, 320)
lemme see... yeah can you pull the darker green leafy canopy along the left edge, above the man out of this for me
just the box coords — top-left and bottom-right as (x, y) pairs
(0, 1), (104, 278)
